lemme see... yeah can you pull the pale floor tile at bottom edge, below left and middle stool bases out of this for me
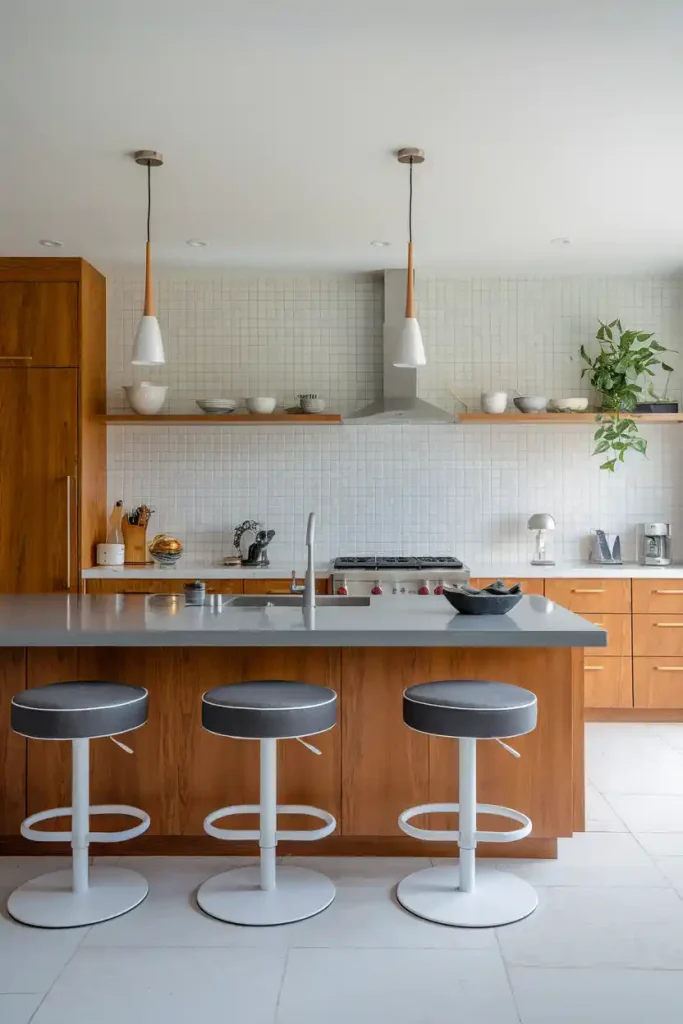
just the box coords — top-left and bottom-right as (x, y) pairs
(32, 948), (285, 1024)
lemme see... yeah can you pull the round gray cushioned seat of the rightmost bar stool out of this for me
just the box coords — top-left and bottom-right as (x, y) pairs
(403, 679), (538, 739)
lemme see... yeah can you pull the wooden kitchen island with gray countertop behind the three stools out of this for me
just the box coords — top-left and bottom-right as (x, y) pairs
(0, 594), (606, 857)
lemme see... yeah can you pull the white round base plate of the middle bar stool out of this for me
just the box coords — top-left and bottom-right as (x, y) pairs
(197, 865), (335, 925)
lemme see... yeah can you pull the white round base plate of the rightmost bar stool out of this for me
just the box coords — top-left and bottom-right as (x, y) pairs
(396, 864), (539, 928)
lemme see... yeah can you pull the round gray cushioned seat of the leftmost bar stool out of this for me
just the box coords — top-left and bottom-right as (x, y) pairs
(11, 682), (148, 739)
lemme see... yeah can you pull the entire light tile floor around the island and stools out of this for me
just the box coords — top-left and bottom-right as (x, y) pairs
(0, 724), (683, 1024)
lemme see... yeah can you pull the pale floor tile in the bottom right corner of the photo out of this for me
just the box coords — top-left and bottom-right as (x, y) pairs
(510, 968), (683, 1024)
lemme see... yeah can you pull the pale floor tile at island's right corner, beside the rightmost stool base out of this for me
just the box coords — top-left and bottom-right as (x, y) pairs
(496, 833), (668, 888)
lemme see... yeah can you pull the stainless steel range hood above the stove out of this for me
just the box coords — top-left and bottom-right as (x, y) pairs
(344, 270), (457, 426)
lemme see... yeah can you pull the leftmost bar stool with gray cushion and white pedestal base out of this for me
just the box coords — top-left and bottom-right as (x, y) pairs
(7, 682), (150, 928)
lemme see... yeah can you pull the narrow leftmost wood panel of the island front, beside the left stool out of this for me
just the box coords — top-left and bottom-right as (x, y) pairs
(0, 647), (27, 836)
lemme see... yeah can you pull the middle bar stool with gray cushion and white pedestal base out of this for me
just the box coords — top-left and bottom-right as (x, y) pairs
(197, 680), (337, 925)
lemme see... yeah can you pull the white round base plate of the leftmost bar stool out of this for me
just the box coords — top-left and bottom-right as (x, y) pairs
(7, 867), (150, 928)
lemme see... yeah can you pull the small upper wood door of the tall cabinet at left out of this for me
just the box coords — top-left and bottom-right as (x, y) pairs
(0, 281), (79, 367)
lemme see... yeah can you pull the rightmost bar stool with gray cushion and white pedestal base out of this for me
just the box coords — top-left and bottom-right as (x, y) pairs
(396, 680), (539, 928)
